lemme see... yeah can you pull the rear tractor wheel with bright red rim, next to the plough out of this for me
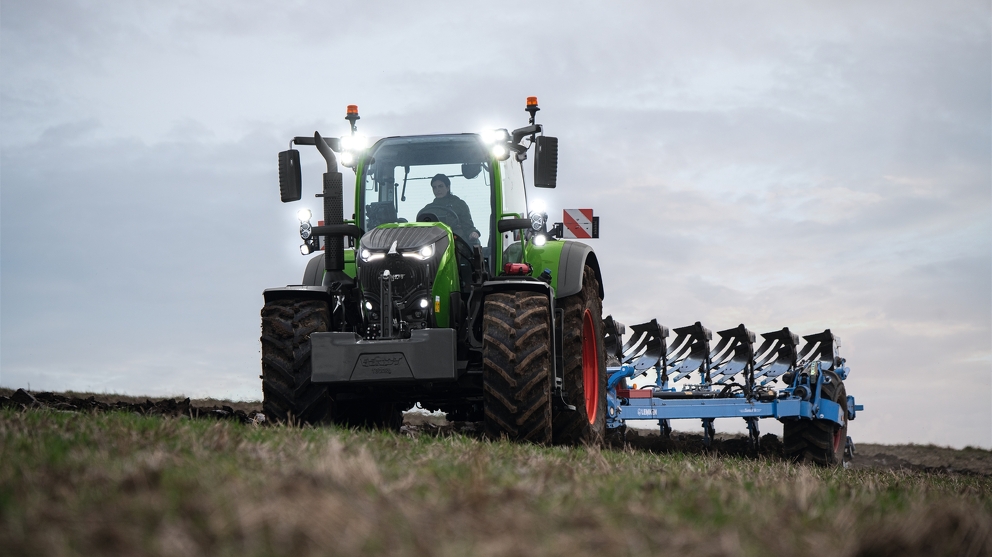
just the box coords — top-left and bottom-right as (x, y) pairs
(553, 267), (606, 446)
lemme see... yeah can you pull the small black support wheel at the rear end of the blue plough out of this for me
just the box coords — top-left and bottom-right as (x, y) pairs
(782, 371), (847, 466)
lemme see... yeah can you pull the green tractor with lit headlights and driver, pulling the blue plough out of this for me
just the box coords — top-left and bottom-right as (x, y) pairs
(261, 97), (607, 444)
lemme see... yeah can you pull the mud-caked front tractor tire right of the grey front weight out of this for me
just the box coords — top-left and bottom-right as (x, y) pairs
(482, 292), (552, 445)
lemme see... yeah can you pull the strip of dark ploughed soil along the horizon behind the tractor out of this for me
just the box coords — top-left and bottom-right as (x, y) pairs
(0, 388), (992, 476)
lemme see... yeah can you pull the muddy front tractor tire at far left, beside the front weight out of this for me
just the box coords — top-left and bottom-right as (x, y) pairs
(262, 300), (331, 425)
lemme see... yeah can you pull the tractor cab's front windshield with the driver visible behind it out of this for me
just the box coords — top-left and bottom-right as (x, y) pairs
(360, 135), (492, 246)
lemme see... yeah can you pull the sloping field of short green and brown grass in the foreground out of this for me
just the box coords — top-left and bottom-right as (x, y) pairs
(0, 409), (992, 557)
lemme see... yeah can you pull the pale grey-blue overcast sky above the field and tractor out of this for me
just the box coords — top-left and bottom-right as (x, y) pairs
(0, 0), (992, 448)
